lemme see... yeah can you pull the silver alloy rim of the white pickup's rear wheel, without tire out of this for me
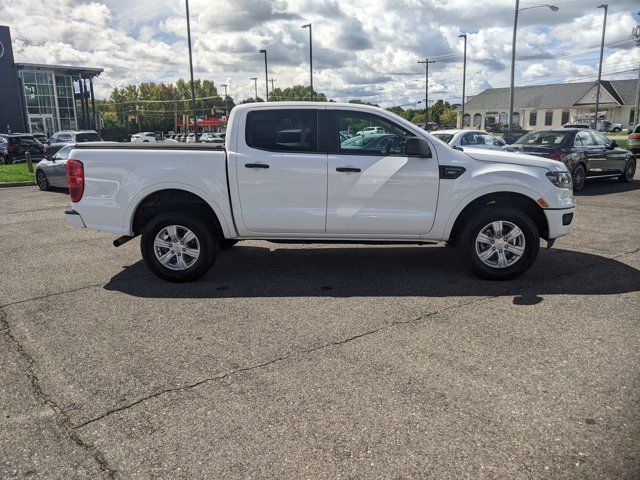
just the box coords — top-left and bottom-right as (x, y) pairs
(153, 225), (200, 271)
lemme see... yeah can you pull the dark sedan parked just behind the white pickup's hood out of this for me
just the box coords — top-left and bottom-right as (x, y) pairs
(504, 128), (636, 191)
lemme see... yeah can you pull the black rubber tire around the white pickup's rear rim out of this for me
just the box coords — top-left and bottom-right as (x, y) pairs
(140, 212), (219, 282)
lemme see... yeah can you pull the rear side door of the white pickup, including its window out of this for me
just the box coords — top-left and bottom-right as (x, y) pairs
(233, 107), (327, 236)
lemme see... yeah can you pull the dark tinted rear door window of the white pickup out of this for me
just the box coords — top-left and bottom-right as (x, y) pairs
(245, 109), (318, 153)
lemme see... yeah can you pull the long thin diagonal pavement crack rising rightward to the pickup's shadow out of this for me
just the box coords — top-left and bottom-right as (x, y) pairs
(69, 248), (640, 428)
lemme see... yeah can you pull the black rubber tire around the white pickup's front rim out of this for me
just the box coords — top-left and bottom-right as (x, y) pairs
(456, 207), (540, 280)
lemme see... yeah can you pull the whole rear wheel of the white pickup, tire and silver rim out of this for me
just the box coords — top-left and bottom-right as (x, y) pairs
(140, 212), (219, 282)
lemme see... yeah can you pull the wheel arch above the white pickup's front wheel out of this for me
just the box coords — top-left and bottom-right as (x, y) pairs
(445, 191), (549, 242)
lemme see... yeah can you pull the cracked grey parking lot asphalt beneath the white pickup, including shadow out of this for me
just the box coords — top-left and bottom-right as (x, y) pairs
(0, 180), (640, 479)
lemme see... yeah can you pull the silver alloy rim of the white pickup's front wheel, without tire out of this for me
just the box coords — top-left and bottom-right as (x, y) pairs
(475, 220), (526, 268)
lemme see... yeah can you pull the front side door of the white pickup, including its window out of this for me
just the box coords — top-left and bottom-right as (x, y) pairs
(327, 109), (439, 238)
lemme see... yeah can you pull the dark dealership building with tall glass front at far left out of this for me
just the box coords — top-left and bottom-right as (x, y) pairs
(0, 25), (103, 136)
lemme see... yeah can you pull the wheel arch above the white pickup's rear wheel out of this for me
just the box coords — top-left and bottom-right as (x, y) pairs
(128, 187), (230, 238)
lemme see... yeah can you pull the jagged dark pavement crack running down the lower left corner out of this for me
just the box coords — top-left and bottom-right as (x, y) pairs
(0, 307), (117, 478)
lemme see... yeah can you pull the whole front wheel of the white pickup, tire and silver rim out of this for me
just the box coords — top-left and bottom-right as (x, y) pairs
(456, 207), (540, 280)
